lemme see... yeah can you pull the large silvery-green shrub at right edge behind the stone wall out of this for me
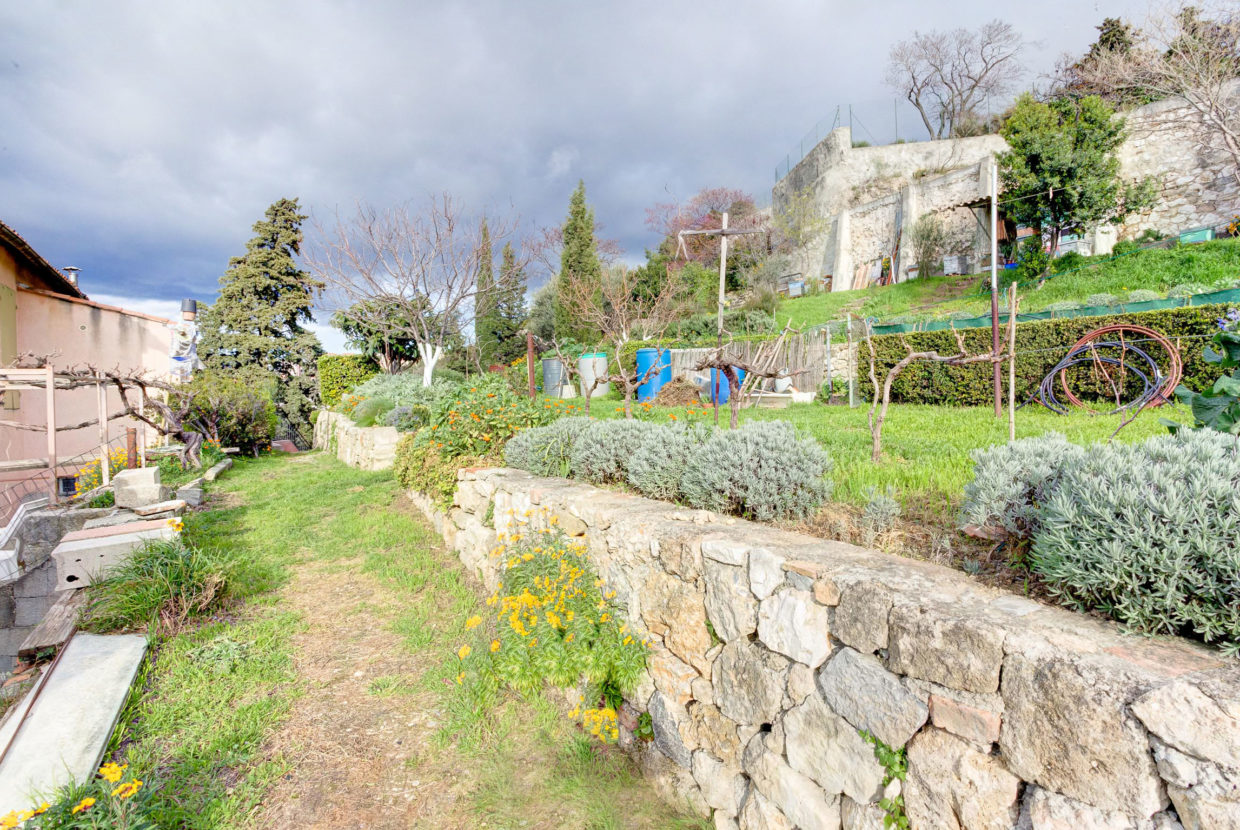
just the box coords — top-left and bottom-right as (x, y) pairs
(1032, 429), (1240, 654)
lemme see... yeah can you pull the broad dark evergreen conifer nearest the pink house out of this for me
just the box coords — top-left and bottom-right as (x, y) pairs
(198, 199), (322, 439)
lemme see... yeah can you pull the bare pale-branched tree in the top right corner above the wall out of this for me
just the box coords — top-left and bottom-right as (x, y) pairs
(1078, 6), (1240, 182)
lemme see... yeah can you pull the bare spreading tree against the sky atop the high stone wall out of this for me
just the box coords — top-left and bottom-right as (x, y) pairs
(887, 20), (1025, 139)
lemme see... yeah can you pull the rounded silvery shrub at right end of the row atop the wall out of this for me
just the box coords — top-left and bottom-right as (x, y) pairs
(681, 421), (831, 521)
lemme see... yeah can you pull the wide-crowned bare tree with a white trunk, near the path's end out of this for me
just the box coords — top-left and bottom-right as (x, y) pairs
(314, 194), (515, 386)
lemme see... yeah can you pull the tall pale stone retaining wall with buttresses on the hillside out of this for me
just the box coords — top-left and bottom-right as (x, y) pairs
(771, 86), (1240, 290)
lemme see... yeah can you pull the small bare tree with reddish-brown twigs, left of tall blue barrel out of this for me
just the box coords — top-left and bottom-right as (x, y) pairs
(559, 267), (681, 418)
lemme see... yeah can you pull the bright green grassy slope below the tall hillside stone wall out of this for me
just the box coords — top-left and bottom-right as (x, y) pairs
(779, 239), (1240, 326)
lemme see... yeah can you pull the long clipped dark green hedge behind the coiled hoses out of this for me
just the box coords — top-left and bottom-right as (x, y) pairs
(858, 305), (1228, 406)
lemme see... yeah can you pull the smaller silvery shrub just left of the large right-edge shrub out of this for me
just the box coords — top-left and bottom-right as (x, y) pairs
(960, 432), (1085, 538)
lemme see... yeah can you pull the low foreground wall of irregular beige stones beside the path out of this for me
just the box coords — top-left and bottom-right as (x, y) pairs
(410, 469), (1240, 830)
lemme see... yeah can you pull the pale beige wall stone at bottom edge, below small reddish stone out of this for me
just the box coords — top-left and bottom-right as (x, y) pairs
(904, 728), (1021, 830)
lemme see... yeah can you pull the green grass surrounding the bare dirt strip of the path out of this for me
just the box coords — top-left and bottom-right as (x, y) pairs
(117, 455), (697, 829)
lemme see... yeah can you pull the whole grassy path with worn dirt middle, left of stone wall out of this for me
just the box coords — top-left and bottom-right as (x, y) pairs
(104, 454), (702, 829)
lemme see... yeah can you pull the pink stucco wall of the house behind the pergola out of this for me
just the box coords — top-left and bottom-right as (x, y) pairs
(0, 289), (170, 466)
